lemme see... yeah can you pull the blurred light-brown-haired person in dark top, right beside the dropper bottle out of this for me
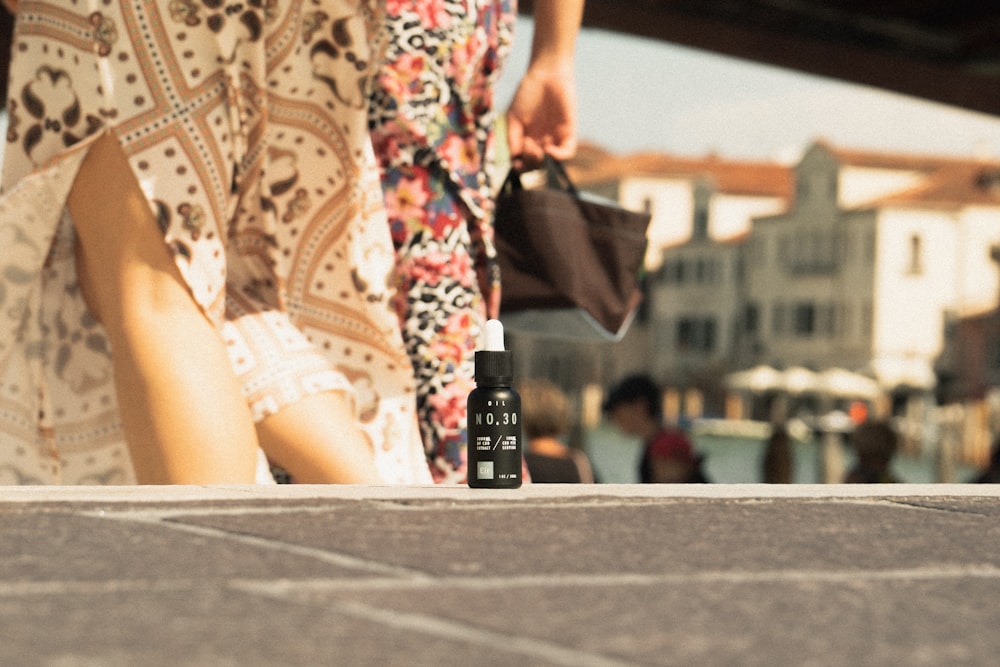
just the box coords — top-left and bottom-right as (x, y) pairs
(518, 379), (594, 484)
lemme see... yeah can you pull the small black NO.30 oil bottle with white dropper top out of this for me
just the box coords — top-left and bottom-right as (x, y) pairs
(467, 320), (522, 489)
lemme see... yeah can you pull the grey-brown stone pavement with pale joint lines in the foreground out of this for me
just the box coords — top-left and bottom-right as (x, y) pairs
(0, 485), (1000, 667)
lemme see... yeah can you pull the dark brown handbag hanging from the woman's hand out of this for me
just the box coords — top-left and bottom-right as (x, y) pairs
(494, 158), (650, 340)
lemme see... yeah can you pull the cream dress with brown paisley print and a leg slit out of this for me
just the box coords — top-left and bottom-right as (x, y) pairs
(0, 0), (430, 484)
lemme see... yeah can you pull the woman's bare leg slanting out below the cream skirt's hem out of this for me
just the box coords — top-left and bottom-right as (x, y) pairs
(257, 392), (383, 484)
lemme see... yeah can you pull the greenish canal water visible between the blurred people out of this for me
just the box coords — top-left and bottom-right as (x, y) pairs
(584, 425), (976, 484)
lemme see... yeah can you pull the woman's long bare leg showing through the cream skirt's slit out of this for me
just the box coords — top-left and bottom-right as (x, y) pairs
(69, 133), (257, 484)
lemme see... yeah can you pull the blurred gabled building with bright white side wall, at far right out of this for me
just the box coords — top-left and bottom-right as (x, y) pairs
(734, 143), (1000, 393)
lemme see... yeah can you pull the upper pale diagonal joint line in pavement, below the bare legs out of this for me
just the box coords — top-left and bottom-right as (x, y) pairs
(93, 512), (431, 580)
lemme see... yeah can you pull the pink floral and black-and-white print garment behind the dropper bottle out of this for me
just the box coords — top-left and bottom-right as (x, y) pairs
(370, 0), (517, 482)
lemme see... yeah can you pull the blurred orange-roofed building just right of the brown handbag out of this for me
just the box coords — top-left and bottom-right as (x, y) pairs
(574, 144), (793, 409)
